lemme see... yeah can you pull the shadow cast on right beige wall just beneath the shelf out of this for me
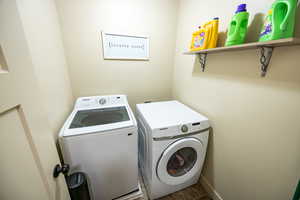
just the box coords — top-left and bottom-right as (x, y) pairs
(192, 46), (300, 90)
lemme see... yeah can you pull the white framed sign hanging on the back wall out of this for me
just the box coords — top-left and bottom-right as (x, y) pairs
(102, 32), (149, 60)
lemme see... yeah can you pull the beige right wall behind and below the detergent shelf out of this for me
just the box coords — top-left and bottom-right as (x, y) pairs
(173, 0), (300, 200)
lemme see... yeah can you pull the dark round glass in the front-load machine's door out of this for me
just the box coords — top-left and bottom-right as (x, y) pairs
(167, 147), (197, 177)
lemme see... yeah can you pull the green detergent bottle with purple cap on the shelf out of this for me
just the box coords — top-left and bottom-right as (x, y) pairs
(225, 4), (249, 46)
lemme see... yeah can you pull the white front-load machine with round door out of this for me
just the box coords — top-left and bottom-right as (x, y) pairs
(137, 101), (209, 199)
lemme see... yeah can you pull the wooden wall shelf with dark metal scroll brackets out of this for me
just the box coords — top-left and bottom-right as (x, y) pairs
(184, 38), (300, 77)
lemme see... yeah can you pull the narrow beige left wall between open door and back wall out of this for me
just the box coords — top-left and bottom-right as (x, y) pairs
(17, 0), (73, 136)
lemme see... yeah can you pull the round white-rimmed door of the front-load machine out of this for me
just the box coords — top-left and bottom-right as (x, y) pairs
(156, 138), (204, 185)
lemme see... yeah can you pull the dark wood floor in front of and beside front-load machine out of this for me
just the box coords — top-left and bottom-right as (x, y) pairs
(137, 178), (212, 200)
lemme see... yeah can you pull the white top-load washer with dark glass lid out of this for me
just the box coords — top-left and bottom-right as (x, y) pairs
(59, 95), (138, 200)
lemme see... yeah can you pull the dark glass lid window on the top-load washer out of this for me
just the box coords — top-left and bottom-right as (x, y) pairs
(70, 106), (130, 129)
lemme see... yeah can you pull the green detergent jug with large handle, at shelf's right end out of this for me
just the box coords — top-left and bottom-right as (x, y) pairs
(259, 0), (297, 41)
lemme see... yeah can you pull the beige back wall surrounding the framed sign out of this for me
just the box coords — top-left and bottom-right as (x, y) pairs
(56, 0), (177, 107)
